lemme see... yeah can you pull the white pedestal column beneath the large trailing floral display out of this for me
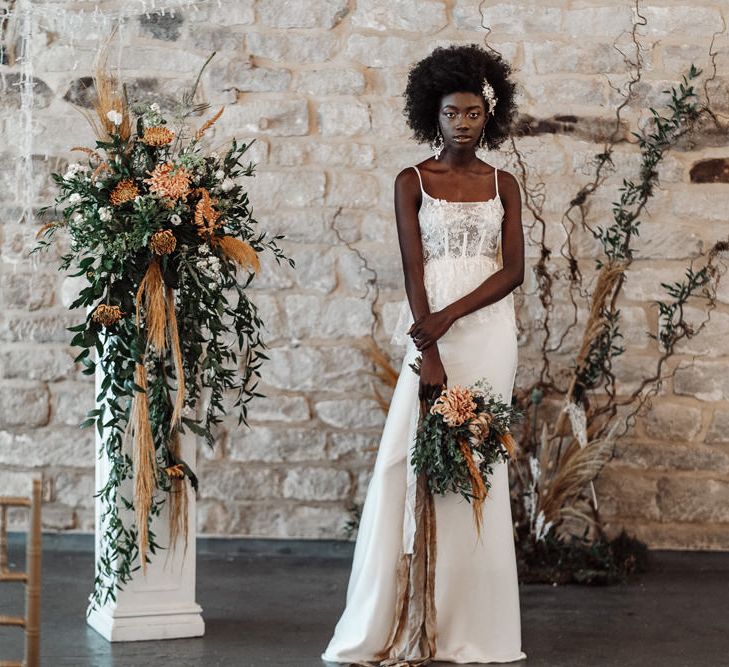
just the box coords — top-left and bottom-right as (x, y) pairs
(88, 368), (205, 642)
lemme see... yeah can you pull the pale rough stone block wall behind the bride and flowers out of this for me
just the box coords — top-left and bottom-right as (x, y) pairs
(0, 0), (729, 549)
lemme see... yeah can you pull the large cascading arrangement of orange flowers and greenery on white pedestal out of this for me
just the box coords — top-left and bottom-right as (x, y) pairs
(33, 56), (293, 604)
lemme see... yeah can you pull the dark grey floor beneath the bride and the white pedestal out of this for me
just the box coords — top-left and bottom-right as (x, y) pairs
(0, 546), (729, 667)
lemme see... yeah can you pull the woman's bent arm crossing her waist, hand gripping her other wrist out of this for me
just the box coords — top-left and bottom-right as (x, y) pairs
(412, 172), (524, 350)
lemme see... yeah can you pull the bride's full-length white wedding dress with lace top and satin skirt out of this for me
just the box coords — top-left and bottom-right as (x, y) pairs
(322, 167), (526, 664)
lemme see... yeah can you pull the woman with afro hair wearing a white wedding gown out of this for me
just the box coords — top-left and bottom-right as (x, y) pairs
(322, 45), (526, 664)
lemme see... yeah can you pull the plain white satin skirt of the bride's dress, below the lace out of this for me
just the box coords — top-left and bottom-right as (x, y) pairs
(322, 318), (526, 664)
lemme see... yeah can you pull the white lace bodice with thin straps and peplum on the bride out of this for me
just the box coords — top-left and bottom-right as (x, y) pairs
(392, 167), (516, 344)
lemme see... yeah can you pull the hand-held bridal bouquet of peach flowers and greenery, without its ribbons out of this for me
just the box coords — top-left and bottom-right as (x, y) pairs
(411, 358), (521, 534)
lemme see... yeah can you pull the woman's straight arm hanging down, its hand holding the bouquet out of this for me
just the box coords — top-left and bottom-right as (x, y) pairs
(395, 168), (447, 399)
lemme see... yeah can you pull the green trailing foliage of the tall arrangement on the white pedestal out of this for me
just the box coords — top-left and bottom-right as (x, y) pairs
(37, 92), (294, 605)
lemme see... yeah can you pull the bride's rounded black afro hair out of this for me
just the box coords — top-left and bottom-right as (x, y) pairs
(403, 44), (516, 149)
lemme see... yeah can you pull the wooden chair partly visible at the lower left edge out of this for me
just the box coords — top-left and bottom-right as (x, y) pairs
(0, 479), (41, 667)
